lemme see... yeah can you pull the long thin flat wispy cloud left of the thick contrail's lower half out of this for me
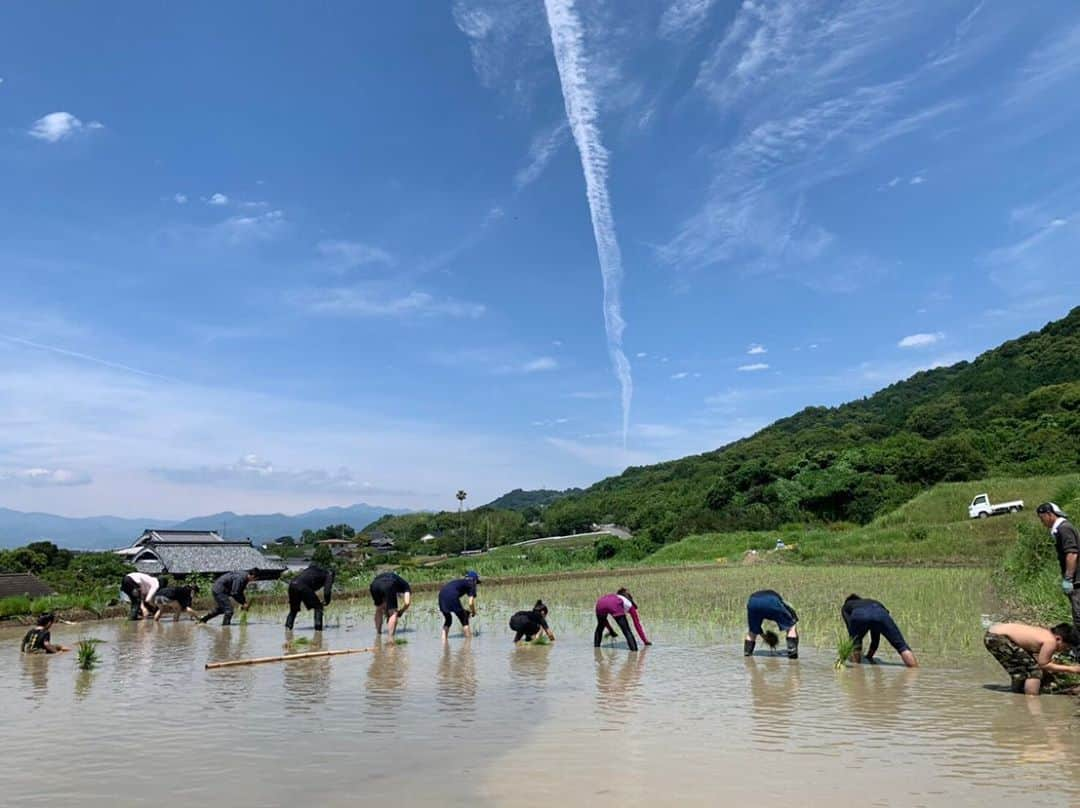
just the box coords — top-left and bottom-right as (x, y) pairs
(291, 285), (486, 320)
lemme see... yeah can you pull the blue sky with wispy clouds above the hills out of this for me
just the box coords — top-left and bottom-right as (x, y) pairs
(0, 0), (1080, 516)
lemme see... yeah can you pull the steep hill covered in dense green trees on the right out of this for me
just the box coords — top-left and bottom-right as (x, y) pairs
(543, 308), (1080, 544)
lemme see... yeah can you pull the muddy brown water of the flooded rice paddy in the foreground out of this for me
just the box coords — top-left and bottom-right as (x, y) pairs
(0, 593), (1080, 808)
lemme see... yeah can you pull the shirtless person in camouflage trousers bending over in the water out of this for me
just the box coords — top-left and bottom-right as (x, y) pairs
(983, 623), (1080, 696)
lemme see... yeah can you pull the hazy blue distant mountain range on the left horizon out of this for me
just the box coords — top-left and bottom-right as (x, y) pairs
(0, 502), (408, 550)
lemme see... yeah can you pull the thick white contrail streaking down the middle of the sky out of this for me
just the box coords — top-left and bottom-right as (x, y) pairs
(544, 0), (634, 446)
